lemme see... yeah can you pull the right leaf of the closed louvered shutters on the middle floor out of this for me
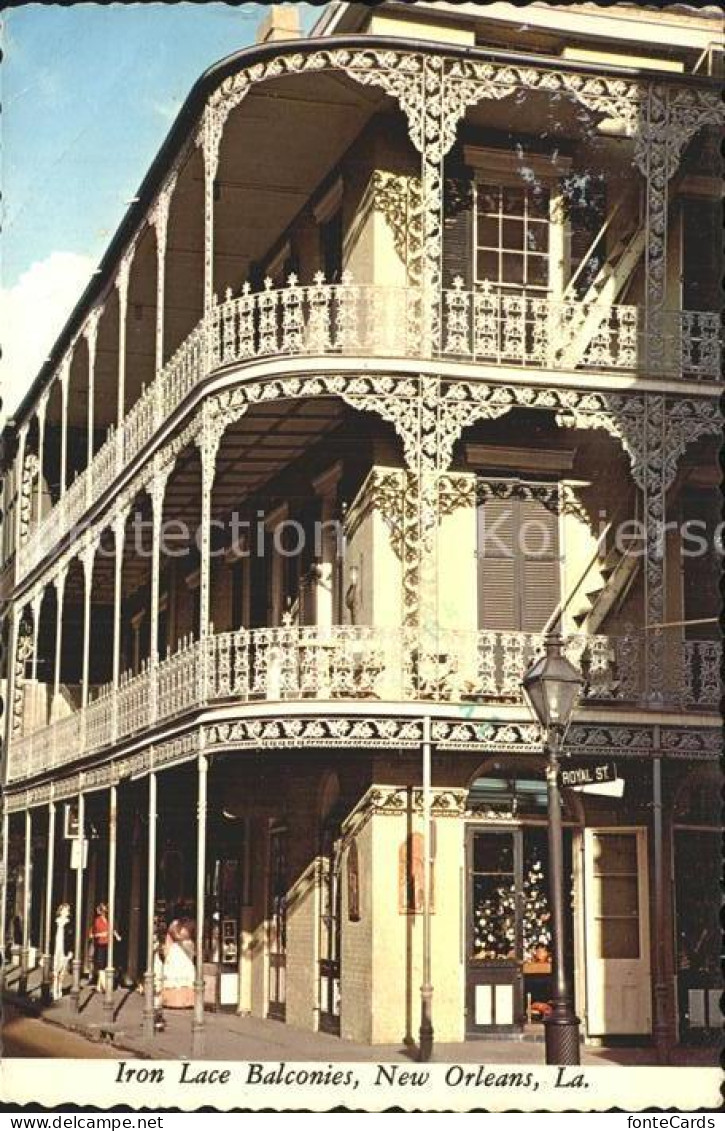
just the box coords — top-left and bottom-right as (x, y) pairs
(518, 499), (560, 632)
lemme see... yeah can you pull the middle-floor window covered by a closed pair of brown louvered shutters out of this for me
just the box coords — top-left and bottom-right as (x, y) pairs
(476, 484), (560, 632)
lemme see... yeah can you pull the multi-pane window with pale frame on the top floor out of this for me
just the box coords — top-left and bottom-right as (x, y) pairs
(474, 182), (550, 291)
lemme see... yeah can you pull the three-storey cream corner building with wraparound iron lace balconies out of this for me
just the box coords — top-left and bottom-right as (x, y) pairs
(0, 3), (722, 1059)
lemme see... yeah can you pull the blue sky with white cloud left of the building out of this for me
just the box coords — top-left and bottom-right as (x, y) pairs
(1, 2), (319, 409)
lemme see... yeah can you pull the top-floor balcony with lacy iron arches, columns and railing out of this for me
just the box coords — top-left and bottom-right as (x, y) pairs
(6, 37), (720, 582)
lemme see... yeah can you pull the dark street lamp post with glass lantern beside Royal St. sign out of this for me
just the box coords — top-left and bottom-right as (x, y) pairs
(523, 633), (584, 1064)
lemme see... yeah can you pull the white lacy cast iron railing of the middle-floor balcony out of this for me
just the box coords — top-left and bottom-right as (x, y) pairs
(9, 624), (722, 780)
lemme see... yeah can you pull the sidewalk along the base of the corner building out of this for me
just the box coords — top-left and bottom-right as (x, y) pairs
(5, 969), (718, 1067)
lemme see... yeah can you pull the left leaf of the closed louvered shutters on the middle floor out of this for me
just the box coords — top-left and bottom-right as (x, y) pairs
(477, 499), (518, 632)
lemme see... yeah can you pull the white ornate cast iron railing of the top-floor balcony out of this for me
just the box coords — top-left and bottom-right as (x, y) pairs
(18, 275), (720, 577)
